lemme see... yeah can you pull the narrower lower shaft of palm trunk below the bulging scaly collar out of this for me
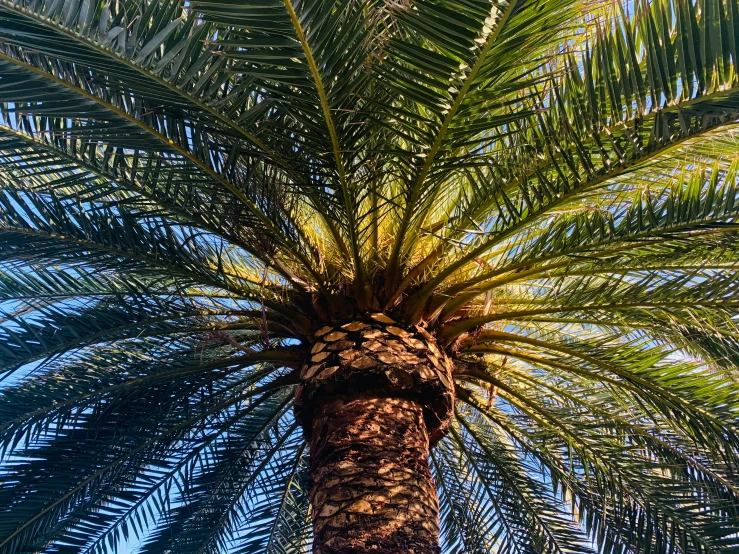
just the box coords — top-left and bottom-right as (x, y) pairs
(311, 397), (440, 554)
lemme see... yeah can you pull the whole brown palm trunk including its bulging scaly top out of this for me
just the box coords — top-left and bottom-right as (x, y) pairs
(295, 314), (454, 554)
